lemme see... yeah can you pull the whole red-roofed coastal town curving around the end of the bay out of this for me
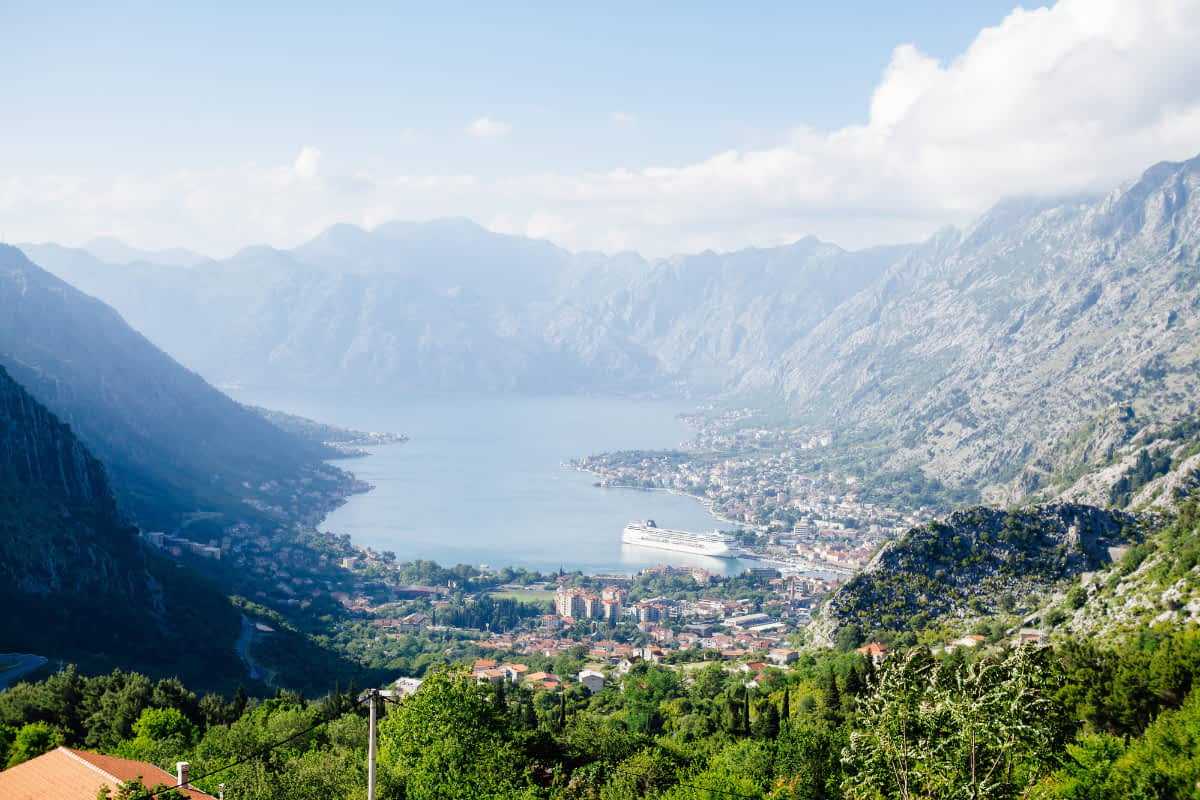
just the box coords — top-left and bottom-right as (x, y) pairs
(133, 411), (955, 688)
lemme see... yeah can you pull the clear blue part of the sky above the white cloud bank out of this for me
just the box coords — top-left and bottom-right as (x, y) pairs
(0, 1), (1012, 174)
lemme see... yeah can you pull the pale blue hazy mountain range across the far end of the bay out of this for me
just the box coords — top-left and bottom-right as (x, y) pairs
(18, 219), (905, 392)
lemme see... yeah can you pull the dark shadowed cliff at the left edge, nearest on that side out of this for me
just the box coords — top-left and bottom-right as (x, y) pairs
(0, 367), (241, 686)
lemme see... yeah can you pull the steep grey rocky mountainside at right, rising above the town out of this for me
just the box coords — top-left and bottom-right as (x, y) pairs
(779, 160), (1200, 501)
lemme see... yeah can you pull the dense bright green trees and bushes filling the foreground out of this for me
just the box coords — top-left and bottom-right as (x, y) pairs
(0, 627), (1200, 800)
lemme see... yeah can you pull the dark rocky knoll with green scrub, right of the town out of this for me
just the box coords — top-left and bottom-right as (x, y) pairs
(808, 504), (1138, 644)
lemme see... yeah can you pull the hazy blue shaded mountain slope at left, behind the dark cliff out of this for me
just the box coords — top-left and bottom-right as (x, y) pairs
(0, 246), (343, 527)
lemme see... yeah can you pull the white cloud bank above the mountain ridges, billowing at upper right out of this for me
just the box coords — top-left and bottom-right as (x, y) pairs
(0, 0), (1200, 254)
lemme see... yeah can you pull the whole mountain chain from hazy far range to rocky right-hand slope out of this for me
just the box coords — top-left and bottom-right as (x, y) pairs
(16, 152), (1200, 500)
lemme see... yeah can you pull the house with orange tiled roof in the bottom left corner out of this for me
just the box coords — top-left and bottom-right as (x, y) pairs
(0, 747), (212, 800)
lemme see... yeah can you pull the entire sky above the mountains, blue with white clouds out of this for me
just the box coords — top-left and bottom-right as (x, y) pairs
(0, 0), (1200, 257)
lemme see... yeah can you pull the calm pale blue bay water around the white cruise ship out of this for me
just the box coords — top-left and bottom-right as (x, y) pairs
(235, 391), (743, 572)
